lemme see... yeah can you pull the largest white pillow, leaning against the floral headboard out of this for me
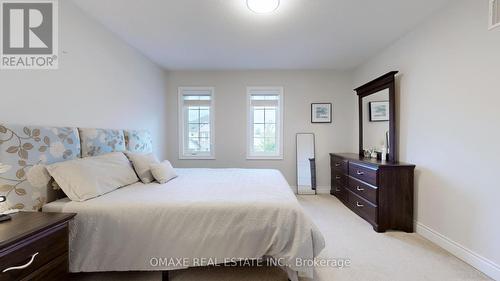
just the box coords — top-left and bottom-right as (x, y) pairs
(47, 152), (139, 202)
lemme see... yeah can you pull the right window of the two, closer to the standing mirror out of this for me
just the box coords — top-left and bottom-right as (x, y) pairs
(247, 87), (283, 159)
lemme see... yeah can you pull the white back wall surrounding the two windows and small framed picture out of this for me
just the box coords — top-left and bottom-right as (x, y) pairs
(167, 71), (354, 190)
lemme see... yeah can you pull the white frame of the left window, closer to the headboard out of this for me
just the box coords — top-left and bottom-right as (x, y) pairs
(177, 87), (215, 160)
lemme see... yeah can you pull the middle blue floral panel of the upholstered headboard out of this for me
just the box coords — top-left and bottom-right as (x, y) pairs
(78, 128), (126, 157)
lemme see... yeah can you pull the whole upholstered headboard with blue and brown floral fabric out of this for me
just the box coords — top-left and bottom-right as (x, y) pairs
(0, 124), (152, 210)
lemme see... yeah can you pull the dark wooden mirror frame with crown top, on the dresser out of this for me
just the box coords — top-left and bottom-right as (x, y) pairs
(354, 71), (398, 162)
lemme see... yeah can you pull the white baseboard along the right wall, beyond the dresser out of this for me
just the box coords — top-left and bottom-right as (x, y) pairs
(416, 222), (500, 281)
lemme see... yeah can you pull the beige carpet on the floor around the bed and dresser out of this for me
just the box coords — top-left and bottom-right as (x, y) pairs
(69, 195), (490, 281)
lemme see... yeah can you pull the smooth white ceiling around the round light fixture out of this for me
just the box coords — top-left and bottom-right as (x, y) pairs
(74, 0), (451, 70)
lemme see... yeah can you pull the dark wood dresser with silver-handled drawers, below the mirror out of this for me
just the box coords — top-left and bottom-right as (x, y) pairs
(330, 153), (415, 232)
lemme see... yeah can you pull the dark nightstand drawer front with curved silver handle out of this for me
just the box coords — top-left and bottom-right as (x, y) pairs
(0, 225), (68, 281)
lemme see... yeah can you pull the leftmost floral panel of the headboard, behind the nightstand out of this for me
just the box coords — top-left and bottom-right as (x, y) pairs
(0, 124), (80, 210)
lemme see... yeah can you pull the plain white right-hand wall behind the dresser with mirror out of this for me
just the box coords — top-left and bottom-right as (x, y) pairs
(354, 0), (500, 280)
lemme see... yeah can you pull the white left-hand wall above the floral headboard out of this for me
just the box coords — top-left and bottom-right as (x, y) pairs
(0, 1), (166, 157)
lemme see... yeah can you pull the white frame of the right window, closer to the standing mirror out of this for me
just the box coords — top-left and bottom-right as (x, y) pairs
(247, 86), (284, 160)
